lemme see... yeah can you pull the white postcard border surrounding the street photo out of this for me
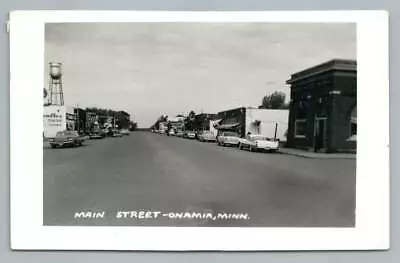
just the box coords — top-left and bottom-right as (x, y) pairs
(10, 11), (389, 250)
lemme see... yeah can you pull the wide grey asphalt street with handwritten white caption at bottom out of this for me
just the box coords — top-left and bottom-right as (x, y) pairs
(43, 131), (356, 227)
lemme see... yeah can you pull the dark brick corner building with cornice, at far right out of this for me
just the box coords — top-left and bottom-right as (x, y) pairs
(287, 59), (357, 152)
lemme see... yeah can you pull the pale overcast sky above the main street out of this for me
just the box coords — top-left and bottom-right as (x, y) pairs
(45, 23), (356, 127)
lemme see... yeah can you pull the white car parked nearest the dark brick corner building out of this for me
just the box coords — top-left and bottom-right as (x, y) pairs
(239, 135), (279, 152)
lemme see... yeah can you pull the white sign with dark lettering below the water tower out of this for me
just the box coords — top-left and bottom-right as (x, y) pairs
(43, 105), (67, 137)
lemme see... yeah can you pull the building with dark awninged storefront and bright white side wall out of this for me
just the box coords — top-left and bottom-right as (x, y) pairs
(214, 107), (289, 141)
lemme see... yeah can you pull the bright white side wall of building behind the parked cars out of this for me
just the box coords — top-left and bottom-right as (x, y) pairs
(245, 108), (289, 141)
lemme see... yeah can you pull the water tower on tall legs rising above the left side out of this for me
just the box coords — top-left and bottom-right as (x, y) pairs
(49, 62), (64, 106)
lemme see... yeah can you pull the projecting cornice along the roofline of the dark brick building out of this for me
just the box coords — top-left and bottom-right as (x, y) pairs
(286, 59), (357, 84)
